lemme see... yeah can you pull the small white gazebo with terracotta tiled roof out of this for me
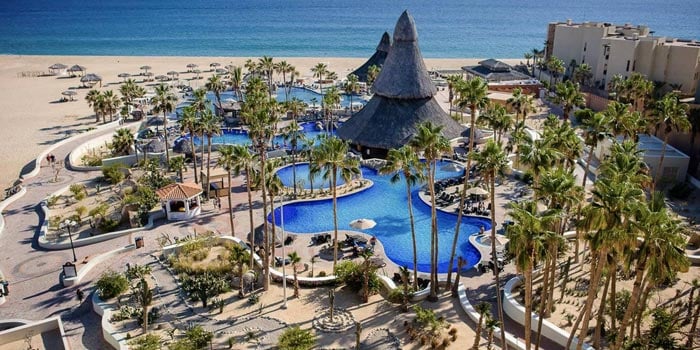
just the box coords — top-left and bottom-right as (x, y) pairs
(156, 183), (202, 221)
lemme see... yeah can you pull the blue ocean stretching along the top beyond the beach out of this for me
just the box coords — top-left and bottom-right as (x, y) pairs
(0, 0), (700, 58)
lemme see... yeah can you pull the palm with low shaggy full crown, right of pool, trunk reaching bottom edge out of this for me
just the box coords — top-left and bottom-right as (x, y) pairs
(506, 201), (555, 349)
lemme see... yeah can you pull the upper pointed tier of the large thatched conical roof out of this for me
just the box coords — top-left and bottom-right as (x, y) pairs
(372, 11), (437, 99)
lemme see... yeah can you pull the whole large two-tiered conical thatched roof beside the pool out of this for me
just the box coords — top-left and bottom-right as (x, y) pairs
(337, 12), (464, 158)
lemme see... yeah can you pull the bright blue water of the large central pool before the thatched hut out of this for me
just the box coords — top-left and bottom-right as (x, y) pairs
(268, 164), (491, 272)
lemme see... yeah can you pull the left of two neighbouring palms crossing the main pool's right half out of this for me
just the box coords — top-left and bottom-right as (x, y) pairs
(379, 146), (425, 290)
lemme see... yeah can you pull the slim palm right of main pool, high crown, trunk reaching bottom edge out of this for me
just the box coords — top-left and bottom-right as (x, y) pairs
(469, 140), (508, 350)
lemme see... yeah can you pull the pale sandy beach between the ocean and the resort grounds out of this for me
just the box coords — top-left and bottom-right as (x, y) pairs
(0, 52), (521, 189)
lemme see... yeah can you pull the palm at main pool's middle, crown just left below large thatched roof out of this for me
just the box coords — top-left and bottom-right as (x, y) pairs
(316, 137), (360, 271)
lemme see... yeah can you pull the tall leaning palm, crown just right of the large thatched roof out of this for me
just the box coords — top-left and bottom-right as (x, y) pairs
(446, 77), (489, 288)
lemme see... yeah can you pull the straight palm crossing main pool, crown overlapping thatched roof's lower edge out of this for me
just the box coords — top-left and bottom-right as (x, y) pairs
(409, 121), (452, 301)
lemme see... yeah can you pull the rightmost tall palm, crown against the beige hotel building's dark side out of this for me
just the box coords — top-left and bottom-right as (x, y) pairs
(652, 93), (690, 187)
